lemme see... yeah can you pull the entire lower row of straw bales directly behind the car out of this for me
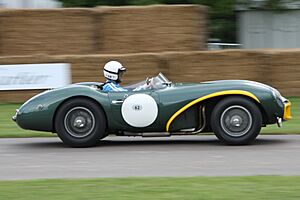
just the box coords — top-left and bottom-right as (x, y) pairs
(0, 50), (300, 102)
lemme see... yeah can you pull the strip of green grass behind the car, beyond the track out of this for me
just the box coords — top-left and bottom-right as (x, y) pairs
(0, 97), (300, 138)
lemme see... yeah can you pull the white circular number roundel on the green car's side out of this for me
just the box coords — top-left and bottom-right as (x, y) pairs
(121, 94), (158, 127)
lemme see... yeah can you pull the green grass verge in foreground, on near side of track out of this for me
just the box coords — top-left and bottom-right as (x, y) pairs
(0, 176), (300, 200)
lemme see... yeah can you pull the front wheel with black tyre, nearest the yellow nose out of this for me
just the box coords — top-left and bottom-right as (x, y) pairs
(211, 97), (262, 145)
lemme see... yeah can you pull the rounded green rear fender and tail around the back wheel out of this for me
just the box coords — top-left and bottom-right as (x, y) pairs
(15, 85), (110, 132)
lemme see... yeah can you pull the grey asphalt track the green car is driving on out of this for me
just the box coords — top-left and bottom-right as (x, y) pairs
(0, 135), (300, 180)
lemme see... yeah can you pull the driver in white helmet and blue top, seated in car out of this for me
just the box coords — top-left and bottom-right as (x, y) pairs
(103, 61), (127, 92)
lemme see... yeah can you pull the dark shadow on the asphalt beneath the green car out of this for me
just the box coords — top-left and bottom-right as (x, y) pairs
(14, 136), (289, 148)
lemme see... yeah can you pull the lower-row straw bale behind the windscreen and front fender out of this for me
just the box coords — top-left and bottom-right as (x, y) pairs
(162, 50), (265, 82)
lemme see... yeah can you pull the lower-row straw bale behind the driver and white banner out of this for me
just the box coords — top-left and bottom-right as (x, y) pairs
(0, 54), (160, 102)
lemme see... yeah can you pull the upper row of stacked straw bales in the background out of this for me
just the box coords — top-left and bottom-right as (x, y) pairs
(0, 5), (207, 56)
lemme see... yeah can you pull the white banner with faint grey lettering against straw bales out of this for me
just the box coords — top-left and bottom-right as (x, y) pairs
(0, 63), (71, 90)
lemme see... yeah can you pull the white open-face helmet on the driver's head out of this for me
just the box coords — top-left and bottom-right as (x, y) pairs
(103, 61), (126, 82)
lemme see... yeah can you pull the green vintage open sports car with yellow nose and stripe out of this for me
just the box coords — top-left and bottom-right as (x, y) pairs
(13, 73), (291, 147)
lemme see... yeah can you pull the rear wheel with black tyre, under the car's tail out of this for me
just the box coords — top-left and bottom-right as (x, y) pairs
(55, 98), (106, 147)
